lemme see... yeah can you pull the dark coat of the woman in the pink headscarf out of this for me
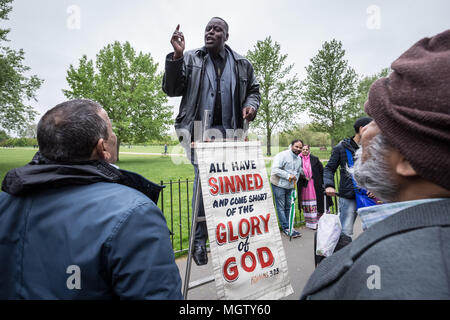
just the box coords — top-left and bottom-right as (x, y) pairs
(297, 154), (332, 213)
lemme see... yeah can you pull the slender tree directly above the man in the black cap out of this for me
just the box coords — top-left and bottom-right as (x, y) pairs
(302, 39), (357, 146)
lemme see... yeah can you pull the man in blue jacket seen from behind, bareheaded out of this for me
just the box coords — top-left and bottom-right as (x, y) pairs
(0, 100), (182, 300)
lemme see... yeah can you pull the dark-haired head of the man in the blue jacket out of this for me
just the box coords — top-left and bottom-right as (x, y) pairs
(37, 99), (117, 163)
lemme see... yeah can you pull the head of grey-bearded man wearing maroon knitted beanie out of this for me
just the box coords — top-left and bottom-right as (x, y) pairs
(353, 30), (450, 201)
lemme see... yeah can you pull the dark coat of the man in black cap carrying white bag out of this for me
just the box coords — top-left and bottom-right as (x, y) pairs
(323, 138), (358, 199)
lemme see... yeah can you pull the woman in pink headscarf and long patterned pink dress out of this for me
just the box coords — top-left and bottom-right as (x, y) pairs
(297, 144), (331, 229)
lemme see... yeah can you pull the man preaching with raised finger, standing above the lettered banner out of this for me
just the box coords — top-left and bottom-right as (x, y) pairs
(162, 17), (260, 265)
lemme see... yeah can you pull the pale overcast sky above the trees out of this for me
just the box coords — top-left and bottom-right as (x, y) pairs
(2, 0), (450, 129)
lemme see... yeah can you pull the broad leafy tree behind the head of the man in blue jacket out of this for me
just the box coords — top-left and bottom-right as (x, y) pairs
(63, 41), (172, 161)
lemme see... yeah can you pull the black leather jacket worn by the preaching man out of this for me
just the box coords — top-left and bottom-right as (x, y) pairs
(162, 46), (261, 141)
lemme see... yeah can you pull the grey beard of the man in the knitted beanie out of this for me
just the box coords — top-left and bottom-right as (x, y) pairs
(347, 134), (398, 202)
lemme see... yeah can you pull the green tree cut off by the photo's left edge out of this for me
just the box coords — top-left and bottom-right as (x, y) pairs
(0, 0), (43, 131)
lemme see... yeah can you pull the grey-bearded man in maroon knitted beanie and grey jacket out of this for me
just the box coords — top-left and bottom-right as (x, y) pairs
(301, 30), (450, 300)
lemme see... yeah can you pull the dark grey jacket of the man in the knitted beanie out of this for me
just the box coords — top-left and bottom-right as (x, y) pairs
(301, 199), (450, 299)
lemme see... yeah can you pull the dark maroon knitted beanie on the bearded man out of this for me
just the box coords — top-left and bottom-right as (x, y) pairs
(364, 30), (450, 190)
